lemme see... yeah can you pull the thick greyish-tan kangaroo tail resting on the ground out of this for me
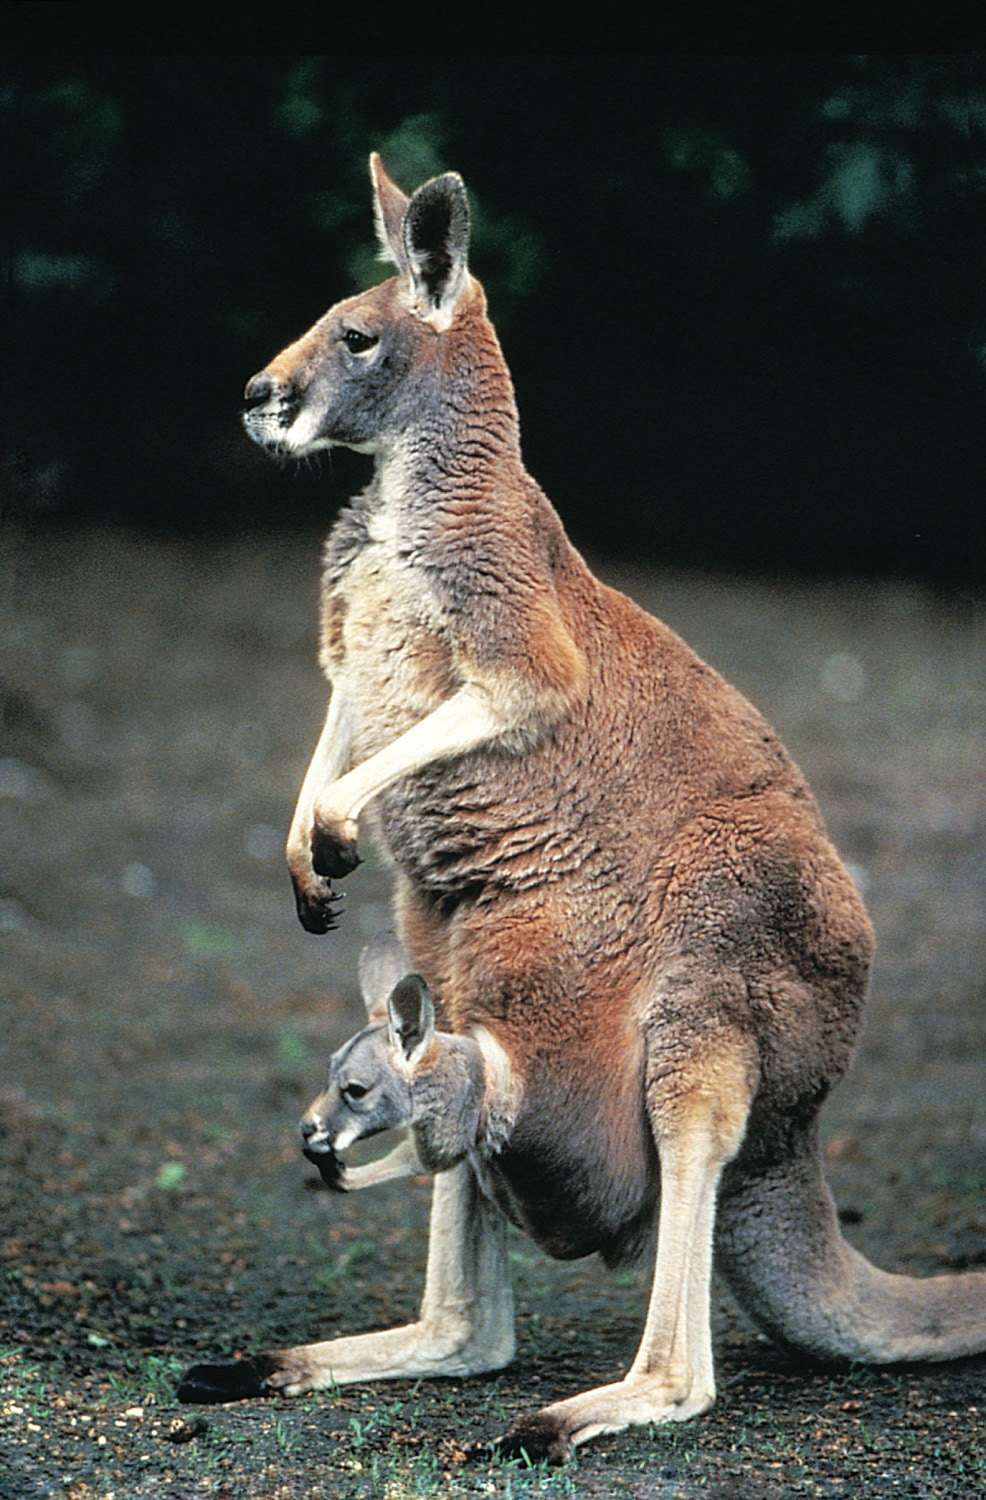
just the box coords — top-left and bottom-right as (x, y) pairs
(716, 1130), (986, 1365)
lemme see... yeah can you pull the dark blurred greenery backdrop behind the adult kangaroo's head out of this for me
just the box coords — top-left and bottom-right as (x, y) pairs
(0, 51), (986, 590)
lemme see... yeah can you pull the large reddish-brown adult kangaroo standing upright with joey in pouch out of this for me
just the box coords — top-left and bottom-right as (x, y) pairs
(183, 156), (986, 1461)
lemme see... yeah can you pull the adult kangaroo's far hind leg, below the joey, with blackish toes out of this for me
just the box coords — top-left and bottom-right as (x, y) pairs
(179, 1163), (513, 1401)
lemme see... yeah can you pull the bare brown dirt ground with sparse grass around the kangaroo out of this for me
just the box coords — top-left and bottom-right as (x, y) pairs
(0, 530), (986, 1500)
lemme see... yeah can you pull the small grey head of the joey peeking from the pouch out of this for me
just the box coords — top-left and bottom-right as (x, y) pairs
(302, 974), (435, 1170)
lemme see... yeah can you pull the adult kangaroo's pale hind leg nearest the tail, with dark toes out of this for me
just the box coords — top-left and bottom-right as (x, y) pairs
(497, 1023), (756, 1463)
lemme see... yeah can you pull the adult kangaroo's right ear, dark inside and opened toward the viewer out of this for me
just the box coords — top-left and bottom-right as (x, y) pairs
(404, 173), (470, 332)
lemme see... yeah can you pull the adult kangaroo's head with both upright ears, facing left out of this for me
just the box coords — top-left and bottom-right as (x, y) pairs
(243, 155), (483, 458)
